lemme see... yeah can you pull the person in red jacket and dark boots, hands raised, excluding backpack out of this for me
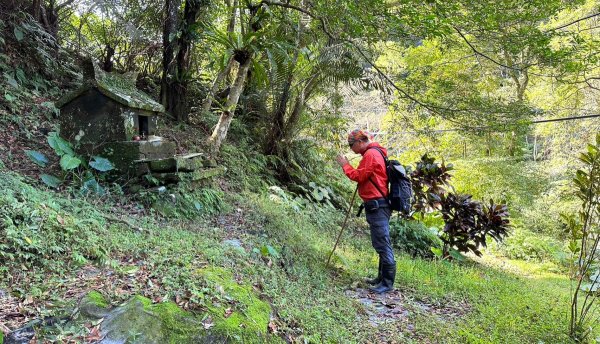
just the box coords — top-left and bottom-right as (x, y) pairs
(337, 129), (396, 294)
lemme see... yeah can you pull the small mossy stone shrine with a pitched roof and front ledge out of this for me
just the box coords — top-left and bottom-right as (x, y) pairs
(56, 60), (222, 182)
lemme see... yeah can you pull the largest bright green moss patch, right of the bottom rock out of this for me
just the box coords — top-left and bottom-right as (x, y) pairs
(199, 268), (271, 339)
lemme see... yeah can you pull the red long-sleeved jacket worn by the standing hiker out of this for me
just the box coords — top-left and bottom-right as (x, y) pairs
(342, 142), (388, 201)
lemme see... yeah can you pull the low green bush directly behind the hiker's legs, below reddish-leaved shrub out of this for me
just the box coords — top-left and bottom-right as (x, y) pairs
(390, 219), (442, 258)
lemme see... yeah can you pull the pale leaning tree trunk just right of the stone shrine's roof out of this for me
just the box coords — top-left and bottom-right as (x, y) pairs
(209, 57), (252, 154)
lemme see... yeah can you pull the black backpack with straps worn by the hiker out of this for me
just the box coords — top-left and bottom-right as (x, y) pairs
(369, 147), (412, 215)
